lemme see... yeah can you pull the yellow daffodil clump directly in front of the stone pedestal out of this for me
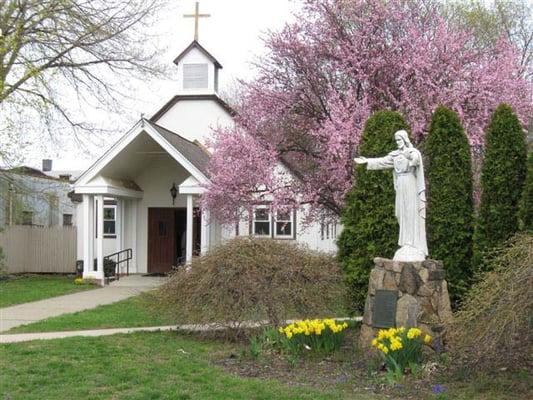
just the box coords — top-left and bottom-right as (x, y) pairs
(372, 326), (432, 374)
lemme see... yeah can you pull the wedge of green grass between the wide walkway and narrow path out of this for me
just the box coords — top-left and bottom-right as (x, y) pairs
(9, 293), (176, 333)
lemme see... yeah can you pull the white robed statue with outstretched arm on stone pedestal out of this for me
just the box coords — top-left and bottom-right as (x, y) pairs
(354, 130), (428, 261)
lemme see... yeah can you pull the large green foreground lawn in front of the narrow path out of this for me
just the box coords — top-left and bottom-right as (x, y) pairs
(0, 332), (376, 400)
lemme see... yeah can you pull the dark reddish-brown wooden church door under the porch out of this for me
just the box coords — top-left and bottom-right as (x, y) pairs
(148, 208), (177, 273)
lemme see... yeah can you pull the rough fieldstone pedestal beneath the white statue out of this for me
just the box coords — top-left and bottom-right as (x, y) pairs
(360, 258), (452, 350)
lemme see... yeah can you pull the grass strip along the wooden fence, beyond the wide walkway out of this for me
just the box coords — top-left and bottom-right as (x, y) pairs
(0, 275), (96, 307)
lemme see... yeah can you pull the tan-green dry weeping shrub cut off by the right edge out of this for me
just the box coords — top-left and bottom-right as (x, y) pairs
(450, 234), (533, 369)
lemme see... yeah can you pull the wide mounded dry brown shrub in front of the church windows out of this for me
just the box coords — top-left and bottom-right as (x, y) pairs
(159, 238), (346, 333)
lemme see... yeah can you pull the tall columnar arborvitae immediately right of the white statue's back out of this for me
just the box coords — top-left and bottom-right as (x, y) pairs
(424, 106), (474, 303)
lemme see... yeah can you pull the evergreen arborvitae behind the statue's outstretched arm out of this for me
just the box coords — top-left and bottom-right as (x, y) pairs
(338, 111), (409, 310)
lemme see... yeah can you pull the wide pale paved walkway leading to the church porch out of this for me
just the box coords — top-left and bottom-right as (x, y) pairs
(0, 275), (165, 332)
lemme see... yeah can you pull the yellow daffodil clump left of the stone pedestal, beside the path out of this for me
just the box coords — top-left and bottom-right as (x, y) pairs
(278, 319), (348, 352)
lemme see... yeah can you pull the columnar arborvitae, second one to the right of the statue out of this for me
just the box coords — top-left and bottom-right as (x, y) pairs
(474, 104), (527, 267)
